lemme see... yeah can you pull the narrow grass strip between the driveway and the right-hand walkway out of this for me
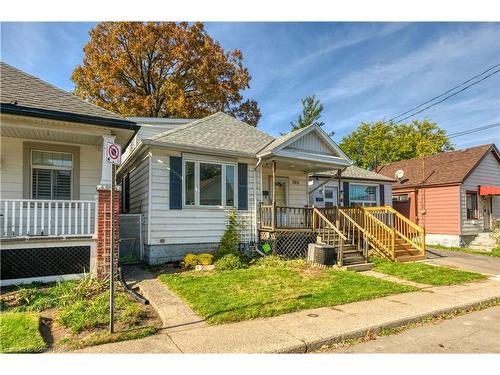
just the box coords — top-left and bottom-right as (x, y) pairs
(370, 257), (486, 285)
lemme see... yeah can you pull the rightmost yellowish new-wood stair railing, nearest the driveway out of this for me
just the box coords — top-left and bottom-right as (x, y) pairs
(364, 206), (425, 256)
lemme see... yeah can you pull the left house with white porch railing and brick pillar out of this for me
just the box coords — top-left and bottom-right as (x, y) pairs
(0, 62), (139, 285)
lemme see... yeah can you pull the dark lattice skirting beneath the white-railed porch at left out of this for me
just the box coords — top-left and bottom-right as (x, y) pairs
(0, 246), (90, 280)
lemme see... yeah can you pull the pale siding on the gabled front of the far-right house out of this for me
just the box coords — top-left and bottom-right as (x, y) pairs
(460, 152), (500, 235)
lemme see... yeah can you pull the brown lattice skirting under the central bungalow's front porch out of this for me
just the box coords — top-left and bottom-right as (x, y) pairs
(259, 231), (316, 259)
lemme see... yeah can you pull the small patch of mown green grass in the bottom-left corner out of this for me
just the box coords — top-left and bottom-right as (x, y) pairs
(0, 313), (46, 353)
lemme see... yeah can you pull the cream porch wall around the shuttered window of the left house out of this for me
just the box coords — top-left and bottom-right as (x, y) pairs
(0, 136), (102, 200)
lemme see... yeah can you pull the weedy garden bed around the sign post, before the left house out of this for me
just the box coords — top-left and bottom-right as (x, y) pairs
(0, 277), (159, 348)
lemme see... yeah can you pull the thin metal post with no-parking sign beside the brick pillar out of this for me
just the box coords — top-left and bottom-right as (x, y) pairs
(106, 142), (122, 333)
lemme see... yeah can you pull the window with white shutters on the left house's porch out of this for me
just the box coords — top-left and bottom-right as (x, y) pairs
(31, 150), (73, 200)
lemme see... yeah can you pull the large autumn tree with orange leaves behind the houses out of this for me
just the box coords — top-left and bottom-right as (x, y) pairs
(71, 22), (261, 126)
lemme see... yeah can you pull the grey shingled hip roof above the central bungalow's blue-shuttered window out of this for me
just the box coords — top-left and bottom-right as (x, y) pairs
(149, 112), (275, 156)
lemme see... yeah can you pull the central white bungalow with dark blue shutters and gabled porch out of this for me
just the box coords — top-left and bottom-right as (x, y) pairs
(118, 112), (352, 264)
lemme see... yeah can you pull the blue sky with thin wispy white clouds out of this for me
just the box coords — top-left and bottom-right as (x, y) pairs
(1, 22), (500, 147)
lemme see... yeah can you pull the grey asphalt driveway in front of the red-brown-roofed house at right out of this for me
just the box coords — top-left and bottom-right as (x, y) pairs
(426, 247), (500, 275)
